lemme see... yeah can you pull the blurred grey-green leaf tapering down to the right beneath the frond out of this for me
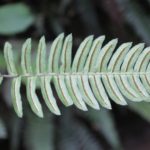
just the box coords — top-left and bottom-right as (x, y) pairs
(85, 109), (121, 150)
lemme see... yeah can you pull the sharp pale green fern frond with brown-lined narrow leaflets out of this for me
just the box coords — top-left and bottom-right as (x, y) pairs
(0, 34), (150, 117)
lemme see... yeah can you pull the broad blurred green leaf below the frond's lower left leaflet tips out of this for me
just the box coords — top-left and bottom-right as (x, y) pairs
(23, 110), (55, 150)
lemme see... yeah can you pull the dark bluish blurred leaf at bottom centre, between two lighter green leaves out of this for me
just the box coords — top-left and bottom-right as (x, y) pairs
(57, 110), (102, 150)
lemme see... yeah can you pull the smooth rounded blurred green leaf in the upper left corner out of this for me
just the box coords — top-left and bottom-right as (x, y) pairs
(0, 3), (35, 35)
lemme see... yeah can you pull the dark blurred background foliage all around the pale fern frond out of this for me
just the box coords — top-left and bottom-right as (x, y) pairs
(0, 0), (150, 150)
